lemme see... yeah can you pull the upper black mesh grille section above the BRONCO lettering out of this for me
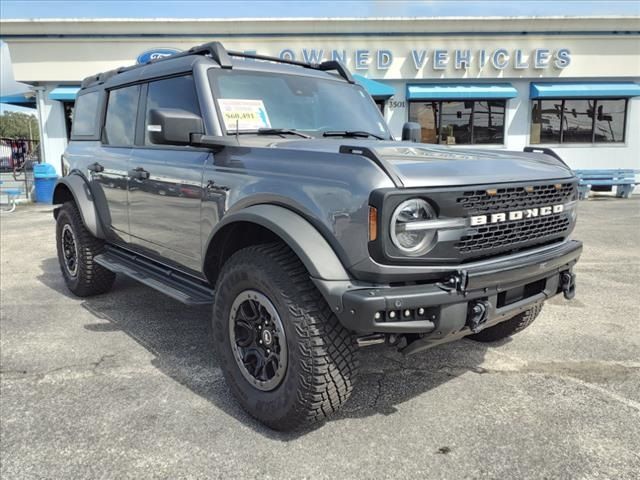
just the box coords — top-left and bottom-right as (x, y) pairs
(456, 183), (577, 215)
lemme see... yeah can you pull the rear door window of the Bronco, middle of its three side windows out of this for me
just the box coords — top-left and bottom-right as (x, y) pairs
(102, 85), (140, 146)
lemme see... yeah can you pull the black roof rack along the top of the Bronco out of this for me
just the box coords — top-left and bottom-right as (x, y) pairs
(80, 42), (355, 88)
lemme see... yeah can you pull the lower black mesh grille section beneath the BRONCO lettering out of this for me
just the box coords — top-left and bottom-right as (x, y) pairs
(455, 213), (571, 254)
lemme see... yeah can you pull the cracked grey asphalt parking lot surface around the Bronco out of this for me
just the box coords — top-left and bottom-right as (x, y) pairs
(0, 196), (640, 480)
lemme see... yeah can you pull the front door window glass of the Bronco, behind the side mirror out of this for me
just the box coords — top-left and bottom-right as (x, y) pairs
(144, 75), (200, 145)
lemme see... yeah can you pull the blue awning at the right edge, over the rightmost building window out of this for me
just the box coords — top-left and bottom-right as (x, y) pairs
(530, 82), (640, 98)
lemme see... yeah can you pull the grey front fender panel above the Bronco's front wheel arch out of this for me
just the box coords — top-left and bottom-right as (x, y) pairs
(202, 147), (393, 268)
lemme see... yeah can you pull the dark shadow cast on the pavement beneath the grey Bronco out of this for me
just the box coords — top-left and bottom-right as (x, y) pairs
(39, 258), (486, 441)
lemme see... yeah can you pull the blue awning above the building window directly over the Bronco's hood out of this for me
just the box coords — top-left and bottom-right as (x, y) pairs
(407, 83), (518, 100)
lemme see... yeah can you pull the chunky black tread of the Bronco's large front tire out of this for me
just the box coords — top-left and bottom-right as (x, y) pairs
(214, 242), (358, 430)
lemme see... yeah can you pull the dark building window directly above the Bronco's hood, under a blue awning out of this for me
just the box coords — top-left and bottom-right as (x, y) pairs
(409, 100), (507, 145)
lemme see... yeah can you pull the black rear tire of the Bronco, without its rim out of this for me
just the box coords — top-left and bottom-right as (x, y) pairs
(56, 202), (116, 297)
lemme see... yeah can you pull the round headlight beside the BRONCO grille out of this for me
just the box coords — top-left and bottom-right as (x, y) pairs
(390, 198), (436, 256)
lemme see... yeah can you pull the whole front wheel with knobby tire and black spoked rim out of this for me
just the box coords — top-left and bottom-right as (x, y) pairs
(213, 243), (357, 430)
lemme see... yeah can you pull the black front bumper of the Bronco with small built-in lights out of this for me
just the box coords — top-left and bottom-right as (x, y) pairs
(337, 240), (582, 343)
